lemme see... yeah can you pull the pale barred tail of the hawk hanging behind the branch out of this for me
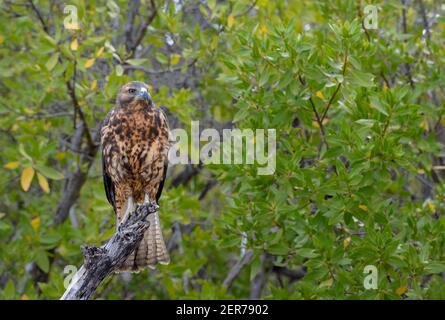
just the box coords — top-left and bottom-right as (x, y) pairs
(117, 212), (170, 272)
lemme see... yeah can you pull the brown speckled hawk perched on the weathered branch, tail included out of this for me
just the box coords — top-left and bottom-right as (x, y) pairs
(101, 81), (170, 271)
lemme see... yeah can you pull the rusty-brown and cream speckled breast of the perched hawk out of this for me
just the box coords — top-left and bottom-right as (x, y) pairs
(102, 108), (169, 197)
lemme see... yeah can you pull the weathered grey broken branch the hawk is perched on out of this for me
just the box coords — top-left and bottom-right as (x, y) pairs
(60, 203), (159, 300)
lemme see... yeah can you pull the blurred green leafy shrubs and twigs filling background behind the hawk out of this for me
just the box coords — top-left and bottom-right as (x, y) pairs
(0, 0), (445, 299)
